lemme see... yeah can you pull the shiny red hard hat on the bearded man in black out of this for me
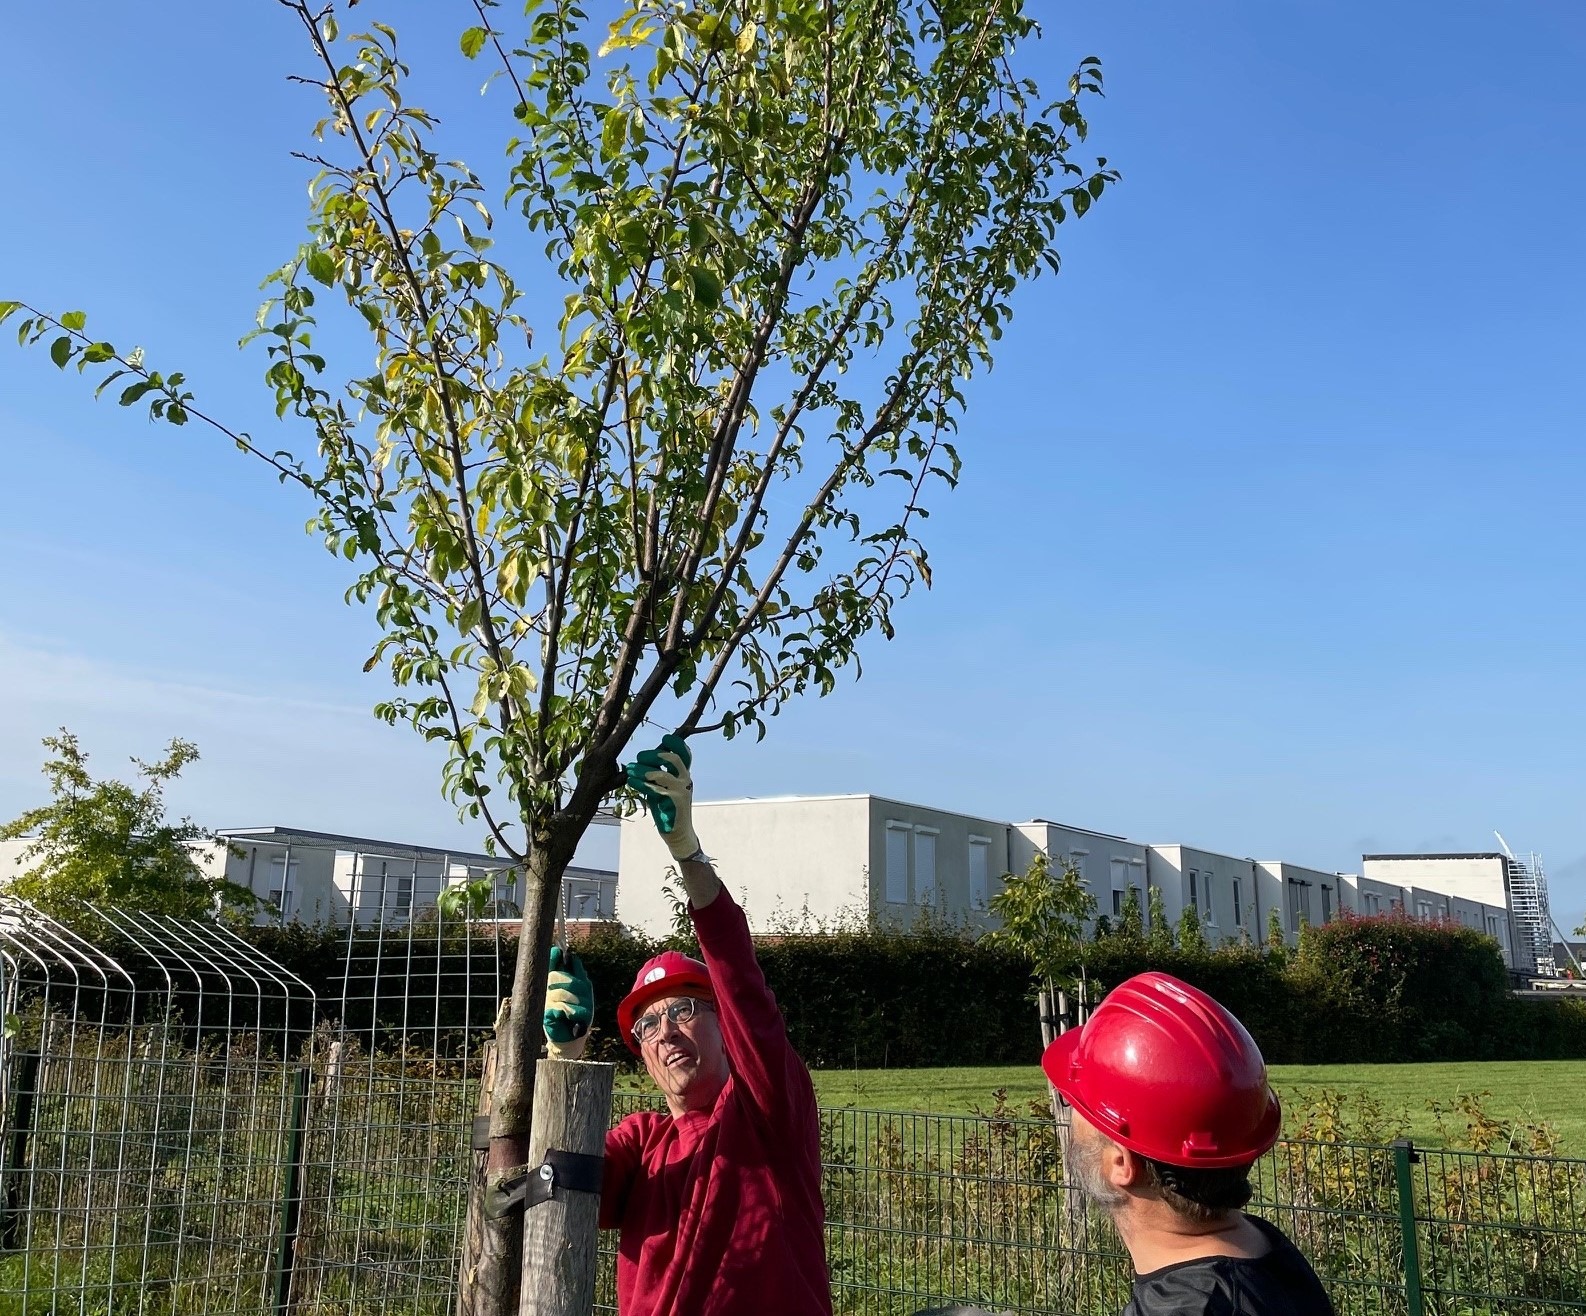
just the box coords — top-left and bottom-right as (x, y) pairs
(1040, 974), (1283, 1170)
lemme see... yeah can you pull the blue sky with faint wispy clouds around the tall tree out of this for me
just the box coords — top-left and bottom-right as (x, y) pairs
(0, 0), (1586, 926)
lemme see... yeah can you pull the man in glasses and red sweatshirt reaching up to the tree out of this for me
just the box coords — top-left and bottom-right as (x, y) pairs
(546, 736), (831, 1316)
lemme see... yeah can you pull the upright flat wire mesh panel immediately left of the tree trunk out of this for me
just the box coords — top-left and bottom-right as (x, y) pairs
(292, 901), (511, 1316)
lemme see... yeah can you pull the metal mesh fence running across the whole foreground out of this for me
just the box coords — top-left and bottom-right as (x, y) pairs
(0, 899), (1586, 1316)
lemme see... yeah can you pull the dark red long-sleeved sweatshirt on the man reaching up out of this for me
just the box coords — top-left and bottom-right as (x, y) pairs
(600, 889), (831, 1316)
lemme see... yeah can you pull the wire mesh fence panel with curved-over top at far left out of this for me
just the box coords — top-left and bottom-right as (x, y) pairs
(0, 901), (314, 1316)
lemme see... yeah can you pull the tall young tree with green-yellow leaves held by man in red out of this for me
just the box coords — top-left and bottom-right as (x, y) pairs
(0, 0), (1115, 1300)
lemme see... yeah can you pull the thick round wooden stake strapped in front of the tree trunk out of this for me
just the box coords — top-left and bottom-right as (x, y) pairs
(519, 1059), (615, 1316)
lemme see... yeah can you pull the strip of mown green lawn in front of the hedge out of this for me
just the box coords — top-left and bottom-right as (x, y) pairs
(799, 1061), (1586, 1156)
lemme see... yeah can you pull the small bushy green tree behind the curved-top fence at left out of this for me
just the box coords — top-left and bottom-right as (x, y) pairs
(0, 728), (257, 923)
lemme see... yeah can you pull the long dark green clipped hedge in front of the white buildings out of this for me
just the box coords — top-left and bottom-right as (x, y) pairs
(241, 915), (1586, 1069)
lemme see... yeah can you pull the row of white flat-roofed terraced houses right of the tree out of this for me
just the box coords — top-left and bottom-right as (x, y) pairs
(617, 794), (1551, 974)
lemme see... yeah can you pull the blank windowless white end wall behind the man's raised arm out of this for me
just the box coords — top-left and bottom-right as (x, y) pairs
(617, 794), (872, 935)
